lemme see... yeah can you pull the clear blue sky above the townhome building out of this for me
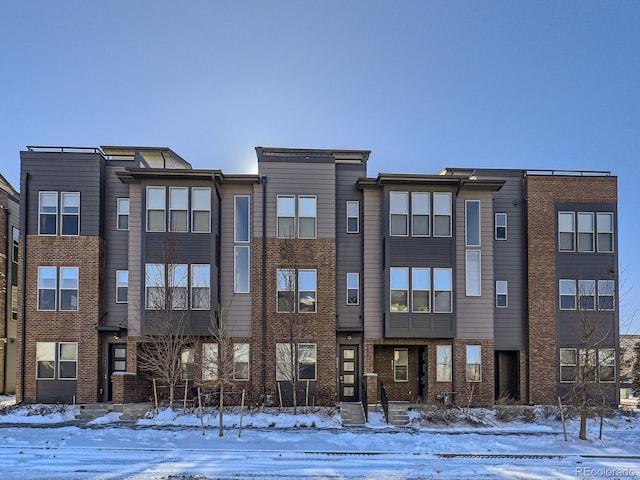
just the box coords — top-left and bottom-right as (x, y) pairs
(0, 0), (640, 333)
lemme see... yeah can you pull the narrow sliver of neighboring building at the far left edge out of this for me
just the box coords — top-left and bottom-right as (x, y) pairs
(0, 175), (20, 395)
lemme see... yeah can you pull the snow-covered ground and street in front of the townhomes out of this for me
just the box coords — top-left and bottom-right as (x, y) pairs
(0, 398), (640, 479)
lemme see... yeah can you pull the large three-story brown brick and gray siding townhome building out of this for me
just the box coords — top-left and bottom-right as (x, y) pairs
(17, 147), (619, 405)
